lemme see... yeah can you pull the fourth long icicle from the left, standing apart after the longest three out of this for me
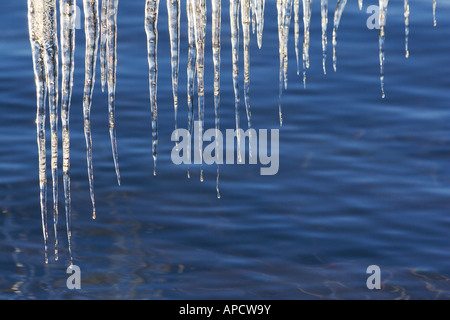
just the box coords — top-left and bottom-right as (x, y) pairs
(83, 0), (99, 219)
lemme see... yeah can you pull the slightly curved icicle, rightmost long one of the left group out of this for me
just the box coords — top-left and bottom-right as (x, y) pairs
(106, 0), (120, 185)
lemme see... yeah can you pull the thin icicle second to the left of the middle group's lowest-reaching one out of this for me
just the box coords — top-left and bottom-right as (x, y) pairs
(186, 0), (197, 179)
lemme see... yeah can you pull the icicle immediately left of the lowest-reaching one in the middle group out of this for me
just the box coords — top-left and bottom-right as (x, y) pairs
(194, 0), (207, 182)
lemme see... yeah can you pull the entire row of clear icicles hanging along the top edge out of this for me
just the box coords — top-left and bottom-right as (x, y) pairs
(28, 0), (442, 263)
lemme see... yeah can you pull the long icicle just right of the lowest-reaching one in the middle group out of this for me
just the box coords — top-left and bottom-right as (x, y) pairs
(230, 0), (242, 162)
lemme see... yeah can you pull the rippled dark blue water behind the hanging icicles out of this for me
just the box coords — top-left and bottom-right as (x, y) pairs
(0, 0), (450, 299)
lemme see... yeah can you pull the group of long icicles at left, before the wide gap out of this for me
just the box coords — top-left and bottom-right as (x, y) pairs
(28, 0), (120, 263)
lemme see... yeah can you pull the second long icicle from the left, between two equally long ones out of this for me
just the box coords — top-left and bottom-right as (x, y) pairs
(41, 0), (59, 260)
